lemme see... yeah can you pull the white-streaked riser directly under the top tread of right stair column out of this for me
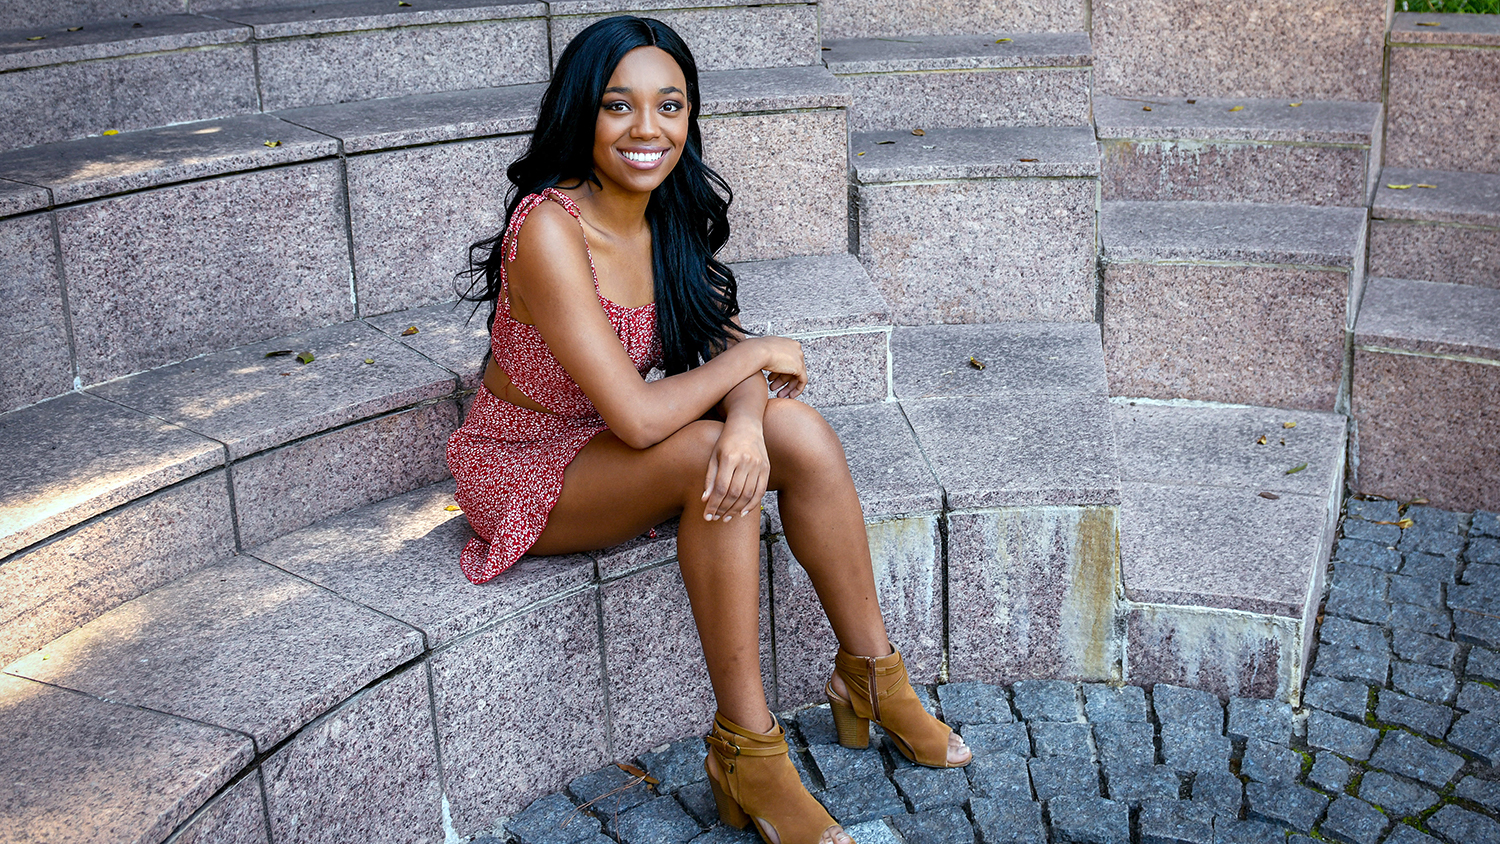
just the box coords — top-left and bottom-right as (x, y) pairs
(1100, 139), (1380, 207)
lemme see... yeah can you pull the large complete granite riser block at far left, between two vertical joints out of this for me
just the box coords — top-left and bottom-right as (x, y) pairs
(57, 162), (353, 384)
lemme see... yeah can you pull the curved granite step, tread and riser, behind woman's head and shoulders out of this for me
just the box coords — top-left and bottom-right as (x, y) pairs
(0, 67), (849, 409)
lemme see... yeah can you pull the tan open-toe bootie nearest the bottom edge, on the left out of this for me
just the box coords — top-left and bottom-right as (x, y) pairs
(704, 714), (839, 844)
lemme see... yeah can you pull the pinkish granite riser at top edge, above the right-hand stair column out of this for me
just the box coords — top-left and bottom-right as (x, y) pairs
(1092, 0), (1386, 102)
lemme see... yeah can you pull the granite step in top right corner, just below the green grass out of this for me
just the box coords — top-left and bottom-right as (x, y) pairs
(1385, 12), (1500, 174)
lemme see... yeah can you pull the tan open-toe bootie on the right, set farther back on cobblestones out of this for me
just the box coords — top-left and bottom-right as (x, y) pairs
(825, 648), (974, 768)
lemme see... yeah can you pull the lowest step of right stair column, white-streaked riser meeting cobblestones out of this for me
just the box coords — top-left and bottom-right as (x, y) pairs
(1110, 399), (1346, 703)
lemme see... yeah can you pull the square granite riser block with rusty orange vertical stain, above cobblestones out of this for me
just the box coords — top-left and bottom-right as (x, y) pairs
(948, 507), (1121, 684)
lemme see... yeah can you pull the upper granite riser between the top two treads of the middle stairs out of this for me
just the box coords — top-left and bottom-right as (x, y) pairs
(839, 67), (1089, 132)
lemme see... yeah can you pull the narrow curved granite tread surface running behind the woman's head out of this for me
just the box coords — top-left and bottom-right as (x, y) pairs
(0, 67), (851, 216)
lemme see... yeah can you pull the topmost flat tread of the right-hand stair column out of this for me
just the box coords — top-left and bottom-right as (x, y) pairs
(1094, 93), (1385, 150)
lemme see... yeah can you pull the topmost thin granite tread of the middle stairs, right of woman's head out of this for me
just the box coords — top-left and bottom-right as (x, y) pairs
(824, 31), (1094, 76)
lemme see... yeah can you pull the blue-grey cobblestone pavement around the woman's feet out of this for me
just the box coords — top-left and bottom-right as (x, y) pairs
(476, 499), (1500, 844)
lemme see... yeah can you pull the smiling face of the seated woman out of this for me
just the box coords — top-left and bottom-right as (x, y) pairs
(594, 46), (692, 193)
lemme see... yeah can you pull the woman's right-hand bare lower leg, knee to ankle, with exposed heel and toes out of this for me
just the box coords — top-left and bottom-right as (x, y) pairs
(764, 399), (969, 765)
